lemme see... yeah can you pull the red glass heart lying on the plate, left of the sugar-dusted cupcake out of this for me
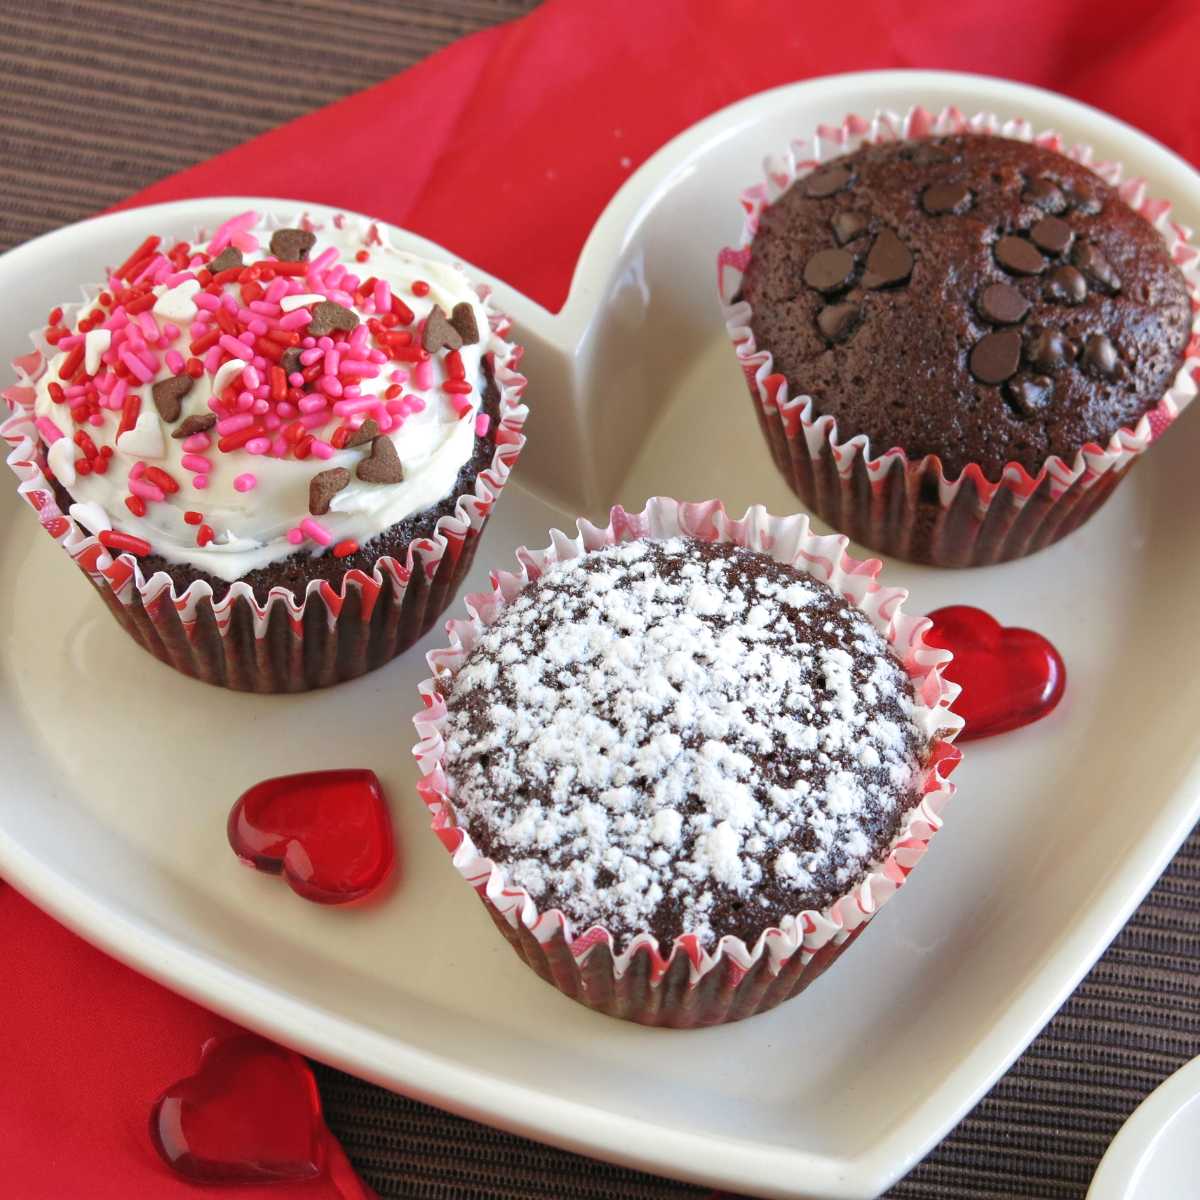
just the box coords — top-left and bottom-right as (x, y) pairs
(228, 769), (396, 904)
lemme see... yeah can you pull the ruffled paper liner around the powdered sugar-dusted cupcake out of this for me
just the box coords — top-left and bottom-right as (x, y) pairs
(414, 497), (962, 1028)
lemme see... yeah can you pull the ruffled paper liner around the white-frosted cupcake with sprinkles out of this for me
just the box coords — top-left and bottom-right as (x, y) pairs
(0, 229), (528, 692)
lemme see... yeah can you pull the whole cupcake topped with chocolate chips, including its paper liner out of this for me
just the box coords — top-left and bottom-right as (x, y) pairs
(721, 110), (1200, 566)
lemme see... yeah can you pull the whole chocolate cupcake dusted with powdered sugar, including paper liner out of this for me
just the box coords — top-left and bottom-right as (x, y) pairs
(416, 500), (961, 1026)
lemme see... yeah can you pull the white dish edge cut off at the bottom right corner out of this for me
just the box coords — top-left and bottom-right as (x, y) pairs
(1087, 1058), (1200, 1200)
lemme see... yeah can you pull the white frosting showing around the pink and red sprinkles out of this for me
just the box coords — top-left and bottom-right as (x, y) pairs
(36, 215), (490, 581)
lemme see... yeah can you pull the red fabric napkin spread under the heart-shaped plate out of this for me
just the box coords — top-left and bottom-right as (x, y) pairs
(7, 0), (1200, 1200)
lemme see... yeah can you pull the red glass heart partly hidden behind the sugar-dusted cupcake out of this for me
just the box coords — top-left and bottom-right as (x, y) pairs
(925, 605), (1067, 742)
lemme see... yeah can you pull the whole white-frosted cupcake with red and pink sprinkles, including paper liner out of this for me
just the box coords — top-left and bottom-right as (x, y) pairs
(2, 212), (526, 691)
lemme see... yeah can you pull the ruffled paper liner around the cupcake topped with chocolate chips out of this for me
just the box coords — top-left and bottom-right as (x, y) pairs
(718, 107), (1200, 566)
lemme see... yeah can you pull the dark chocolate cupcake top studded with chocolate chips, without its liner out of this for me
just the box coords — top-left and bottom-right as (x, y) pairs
(742, 134), (1192, 480)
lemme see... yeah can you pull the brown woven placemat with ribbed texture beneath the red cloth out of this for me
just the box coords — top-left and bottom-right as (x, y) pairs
(0, 0), (1200, 1200)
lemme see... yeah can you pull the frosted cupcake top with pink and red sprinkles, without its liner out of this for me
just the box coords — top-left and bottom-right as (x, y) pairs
(36, 212), (503, 581)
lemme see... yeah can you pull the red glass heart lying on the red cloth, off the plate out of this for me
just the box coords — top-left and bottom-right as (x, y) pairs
(150, 1033), (330, 1184)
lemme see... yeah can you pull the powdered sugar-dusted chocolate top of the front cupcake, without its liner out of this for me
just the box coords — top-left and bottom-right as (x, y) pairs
(443, 536), (930, 947)
